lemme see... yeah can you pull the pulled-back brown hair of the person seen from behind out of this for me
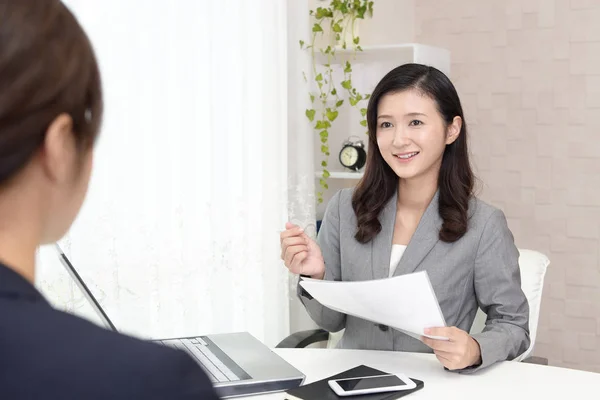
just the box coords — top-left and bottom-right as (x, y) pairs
(0, 0), (102, 185)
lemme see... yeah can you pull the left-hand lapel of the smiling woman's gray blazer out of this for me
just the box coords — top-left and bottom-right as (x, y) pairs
(371, 191), (398, 279)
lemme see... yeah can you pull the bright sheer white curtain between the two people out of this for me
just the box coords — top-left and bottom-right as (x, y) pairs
(38, 0), (289, 345)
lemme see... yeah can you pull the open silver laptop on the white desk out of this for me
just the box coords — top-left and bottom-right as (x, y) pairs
(55, 244), (305, 398)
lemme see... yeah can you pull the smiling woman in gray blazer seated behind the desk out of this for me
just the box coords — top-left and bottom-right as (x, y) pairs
(281, 64), (529, 371)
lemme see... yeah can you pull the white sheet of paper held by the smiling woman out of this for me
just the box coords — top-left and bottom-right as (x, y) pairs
(300, 271), (447, 339)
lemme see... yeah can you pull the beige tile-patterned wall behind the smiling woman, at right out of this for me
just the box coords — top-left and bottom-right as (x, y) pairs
(414, 0), (600, 371)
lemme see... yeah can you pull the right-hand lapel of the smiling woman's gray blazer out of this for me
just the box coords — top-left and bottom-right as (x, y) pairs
(390, 192), (442, 276)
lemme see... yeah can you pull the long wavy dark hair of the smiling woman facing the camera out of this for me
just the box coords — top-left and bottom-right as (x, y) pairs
(352, 64), (474, 243)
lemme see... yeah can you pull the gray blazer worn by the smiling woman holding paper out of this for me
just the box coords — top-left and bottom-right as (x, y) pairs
(299, 189), (529, 371)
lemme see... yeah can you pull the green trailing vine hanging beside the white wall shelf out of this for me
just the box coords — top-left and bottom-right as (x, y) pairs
(300, 0), (373, 203)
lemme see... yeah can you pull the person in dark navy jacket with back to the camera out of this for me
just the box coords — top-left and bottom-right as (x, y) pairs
(0, 0), (217, 400)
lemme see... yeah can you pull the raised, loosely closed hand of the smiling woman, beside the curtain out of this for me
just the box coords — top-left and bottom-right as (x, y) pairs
(280, 222), (325, 279)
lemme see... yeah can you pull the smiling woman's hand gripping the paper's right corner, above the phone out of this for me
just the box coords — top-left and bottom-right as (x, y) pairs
(421, 327), (481, 370)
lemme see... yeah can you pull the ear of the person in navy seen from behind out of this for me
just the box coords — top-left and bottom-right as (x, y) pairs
(42, 113), (77, 182)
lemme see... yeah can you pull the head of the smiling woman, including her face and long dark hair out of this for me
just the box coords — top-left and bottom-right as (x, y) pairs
(353, 64), (473, 243)
